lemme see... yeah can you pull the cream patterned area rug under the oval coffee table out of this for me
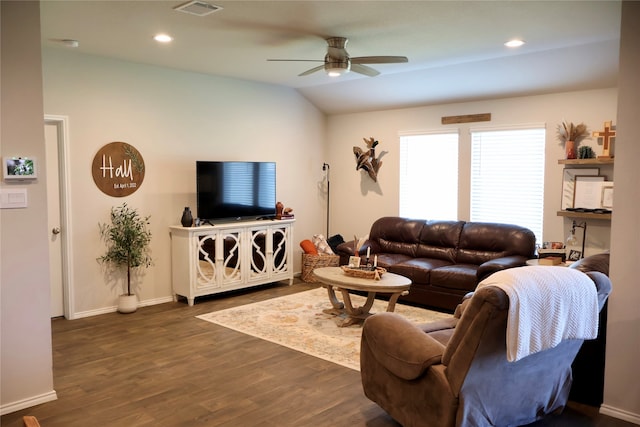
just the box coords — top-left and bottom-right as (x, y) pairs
(196, 288), (451, 370)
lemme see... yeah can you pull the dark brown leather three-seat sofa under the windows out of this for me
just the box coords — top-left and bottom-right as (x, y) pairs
(337, 217), (536, 311)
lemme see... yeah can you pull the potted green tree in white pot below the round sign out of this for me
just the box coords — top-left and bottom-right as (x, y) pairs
(98, 203), (153, 313)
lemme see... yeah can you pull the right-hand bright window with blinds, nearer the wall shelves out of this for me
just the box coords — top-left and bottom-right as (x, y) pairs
(469, 125), (545, 242)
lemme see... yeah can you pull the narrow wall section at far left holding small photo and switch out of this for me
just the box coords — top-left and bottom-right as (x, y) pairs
(0, 1), (56, 413)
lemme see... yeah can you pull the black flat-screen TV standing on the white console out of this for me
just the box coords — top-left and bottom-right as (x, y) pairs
(196, 161), (276, 223)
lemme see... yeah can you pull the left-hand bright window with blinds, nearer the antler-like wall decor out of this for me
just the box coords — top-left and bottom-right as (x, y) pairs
(399, 133), (458, 220)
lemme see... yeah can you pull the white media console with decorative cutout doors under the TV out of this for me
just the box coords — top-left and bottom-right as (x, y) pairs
(169, 219), (295, 306)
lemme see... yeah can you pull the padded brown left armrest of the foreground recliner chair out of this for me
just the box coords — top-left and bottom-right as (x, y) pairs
(362, 312), (445, 380)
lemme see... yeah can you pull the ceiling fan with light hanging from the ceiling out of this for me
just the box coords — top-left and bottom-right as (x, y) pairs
(267, 37), (409, 77)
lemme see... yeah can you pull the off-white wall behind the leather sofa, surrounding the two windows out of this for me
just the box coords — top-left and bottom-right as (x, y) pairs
(328, 89), (617, 255)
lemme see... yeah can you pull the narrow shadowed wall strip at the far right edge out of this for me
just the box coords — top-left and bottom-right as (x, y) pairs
(603, 1), (640, 424)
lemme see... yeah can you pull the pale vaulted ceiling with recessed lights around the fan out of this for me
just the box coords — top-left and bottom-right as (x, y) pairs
(41, 0), (620, 114)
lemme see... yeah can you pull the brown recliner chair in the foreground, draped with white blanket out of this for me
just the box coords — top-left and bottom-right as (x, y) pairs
(360, 272), (611, 427)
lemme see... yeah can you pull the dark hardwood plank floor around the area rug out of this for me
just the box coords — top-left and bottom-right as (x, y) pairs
(0, 281), (633, 427)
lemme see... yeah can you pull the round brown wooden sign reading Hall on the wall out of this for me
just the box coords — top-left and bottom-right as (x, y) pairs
(91, 142), (144, 197)
